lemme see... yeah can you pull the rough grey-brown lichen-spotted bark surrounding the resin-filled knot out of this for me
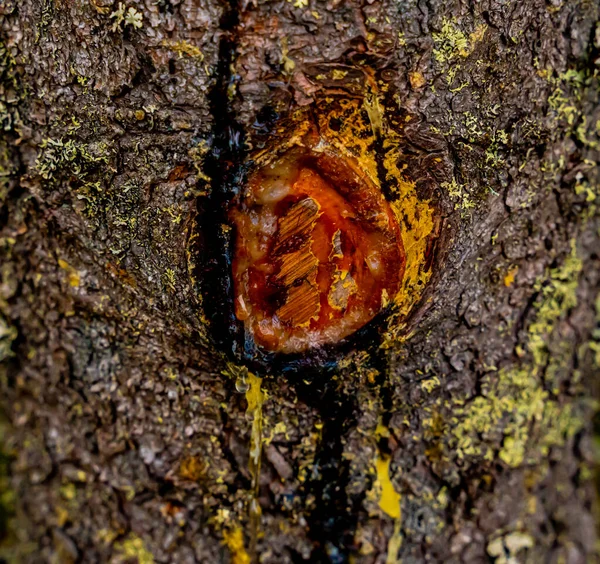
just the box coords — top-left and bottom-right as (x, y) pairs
(0, 0), (600, 563)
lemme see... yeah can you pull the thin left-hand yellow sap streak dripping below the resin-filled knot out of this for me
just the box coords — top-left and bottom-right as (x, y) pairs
(246, 372), (267, 555)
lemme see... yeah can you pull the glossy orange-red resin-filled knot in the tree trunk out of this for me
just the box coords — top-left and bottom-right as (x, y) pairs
(231, 144), (405, 353)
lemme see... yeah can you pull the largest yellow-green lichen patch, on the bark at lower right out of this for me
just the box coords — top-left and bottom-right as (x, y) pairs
(451, 244), (583, 467)
